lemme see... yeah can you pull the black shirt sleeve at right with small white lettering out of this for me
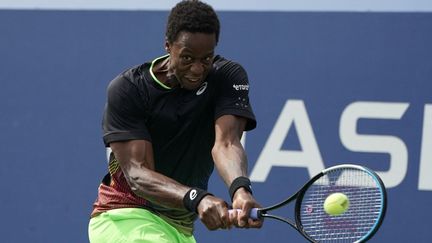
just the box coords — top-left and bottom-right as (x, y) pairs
(215, 62), (256, 131)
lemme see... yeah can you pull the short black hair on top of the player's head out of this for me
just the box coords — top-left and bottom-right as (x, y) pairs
(165, 0), (220, 43)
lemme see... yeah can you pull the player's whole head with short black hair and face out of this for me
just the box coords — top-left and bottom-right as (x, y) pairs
(165, 0), (220, 90)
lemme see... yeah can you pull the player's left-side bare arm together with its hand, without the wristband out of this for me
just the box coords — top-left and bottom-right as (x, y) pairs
(110, 140), (229, 230)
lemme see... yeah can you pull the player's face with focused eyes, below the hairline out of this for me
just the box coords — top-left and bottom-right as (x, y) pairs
(165, 32), (216, 90)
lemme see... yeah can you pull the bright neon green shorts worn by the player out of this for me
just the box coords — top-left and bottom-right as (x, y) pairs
(88, 208), (196, 243)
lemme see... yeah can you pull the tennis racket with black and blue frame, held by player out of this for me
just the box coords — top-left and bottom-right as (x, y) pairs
(231, 164), (387, 242)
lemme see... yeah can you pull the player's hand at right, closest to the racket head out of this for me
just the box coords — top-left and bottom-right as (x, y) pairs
(230, 188), (263, 228)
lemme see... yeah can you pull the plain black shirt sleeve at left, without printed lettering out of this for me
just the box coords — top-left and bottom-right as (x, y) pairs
(102, 75), (151, 147)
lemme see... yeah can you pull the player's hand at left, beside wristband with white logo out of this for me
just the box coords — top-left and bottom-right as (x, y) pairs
(197, 195), (232, 230)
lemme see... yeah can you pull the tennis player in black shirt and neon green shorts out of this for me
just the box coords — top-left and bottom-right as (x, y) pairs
(89, 0), (262, 243)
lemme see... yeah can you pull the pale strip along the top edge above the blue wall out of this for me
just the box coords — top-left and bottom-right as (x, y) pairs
(0, 0), (432, 12)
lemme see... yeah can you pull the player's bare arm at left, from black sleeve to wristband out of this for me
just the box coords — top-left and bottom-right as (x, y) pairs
(110, 140), (189, 208)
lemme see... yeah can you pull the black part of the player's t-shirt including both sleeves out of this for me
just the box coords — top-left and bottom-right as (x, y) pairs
(103, 56), (256, 189)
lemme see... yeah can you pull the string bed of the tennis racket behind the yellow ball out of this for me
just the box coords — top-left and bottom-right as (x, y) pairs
(300, 168), (383, 242)
